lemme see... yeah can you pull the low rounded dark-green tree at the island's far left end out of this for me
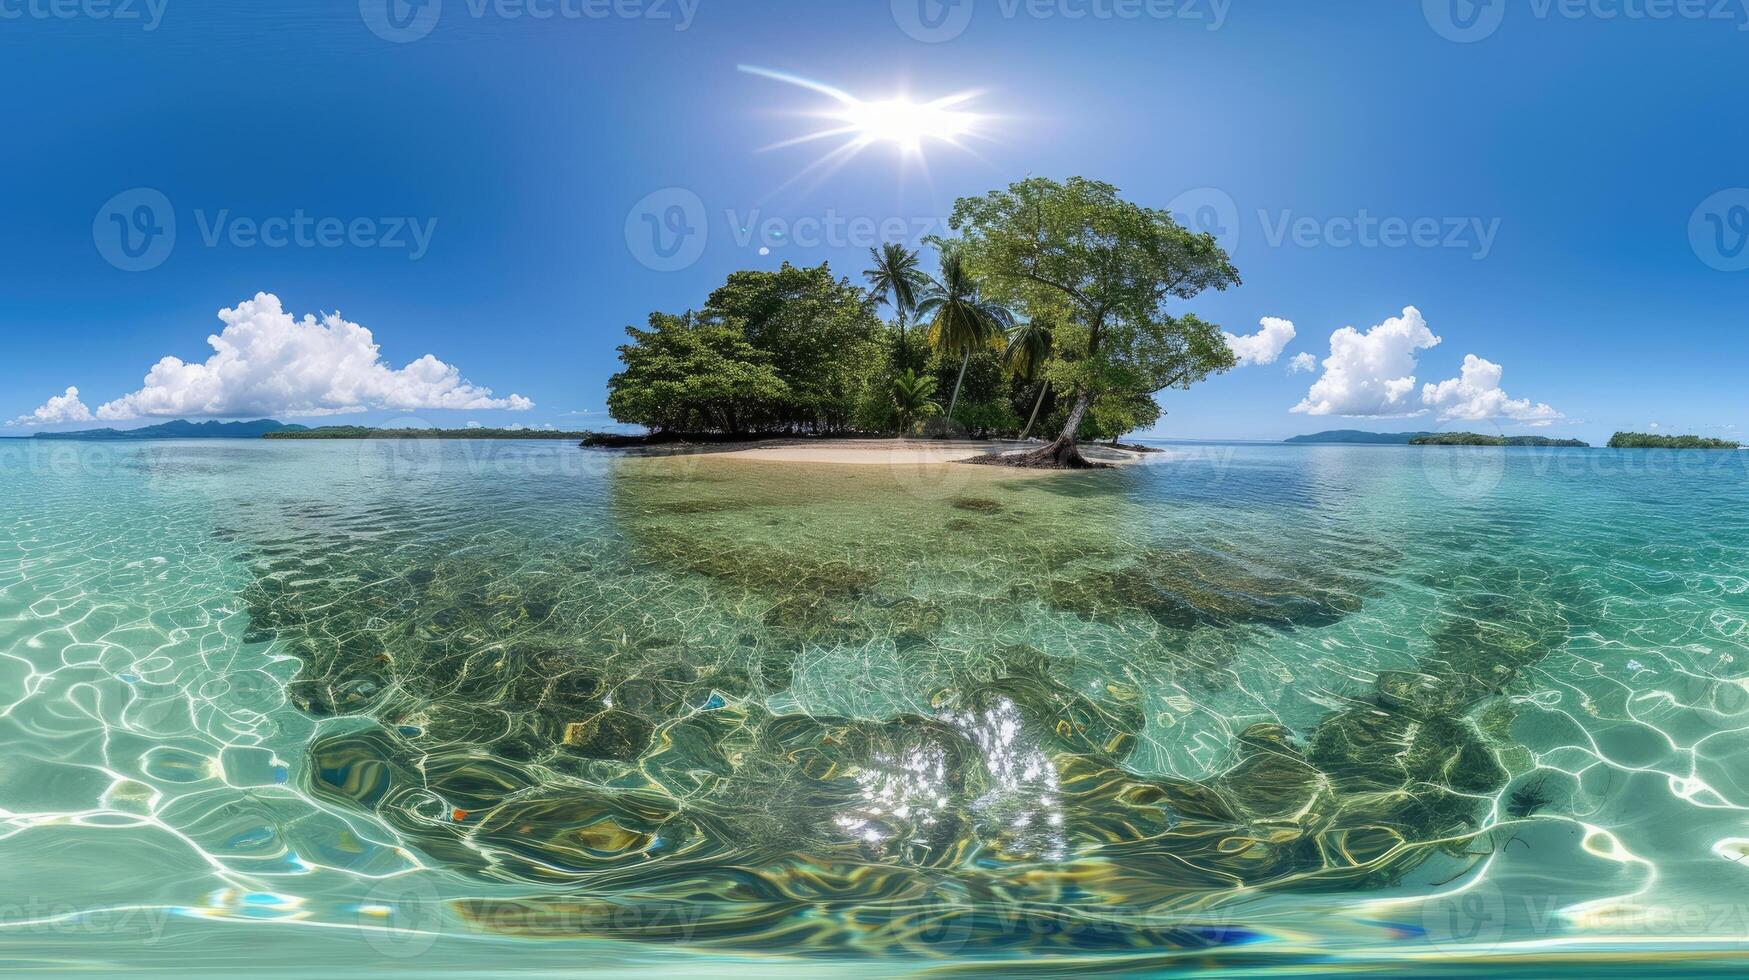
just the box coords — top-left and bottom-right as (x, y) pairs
(607, 313), (789, 432)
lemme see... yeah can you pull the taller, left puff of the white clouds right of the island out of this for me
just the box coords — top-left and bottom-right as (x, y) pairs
(1291, 306), (1439, 417)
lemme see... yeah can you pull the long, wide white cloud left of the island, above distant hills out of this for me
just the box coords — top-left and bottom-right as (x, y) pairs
(83, 292), (533, 418)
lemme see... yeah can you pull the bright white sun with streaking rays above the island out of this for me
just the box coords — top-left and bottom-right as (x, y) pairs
(740, 65), (988, 173)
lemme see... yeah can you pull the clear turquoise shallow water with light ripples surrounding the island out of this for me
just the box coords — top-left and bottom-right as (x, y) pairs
(0, 443), (1749, 975)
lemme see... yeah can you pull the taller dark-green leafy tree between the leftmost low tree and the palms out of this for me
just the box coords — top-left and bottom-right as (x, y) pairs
(703, 263), (883, 432)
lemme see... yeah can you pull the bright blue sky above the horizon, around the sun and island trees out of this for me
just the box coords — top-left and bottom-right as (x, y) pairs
(0, 0), (1749, 441)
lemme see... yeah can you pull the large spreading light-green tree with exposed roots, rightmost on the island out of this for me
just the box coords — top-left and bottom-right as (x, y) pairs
(948, 177), (1240, 466)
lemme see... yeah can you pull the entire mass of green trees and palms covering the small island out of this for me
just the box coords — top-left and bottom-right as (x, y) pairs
(607, 179), (1238, 455)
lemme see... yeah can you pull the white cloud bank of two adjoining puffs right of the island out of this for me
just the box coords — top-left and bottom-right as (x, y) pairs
(1291, 306), (1565, 425)
